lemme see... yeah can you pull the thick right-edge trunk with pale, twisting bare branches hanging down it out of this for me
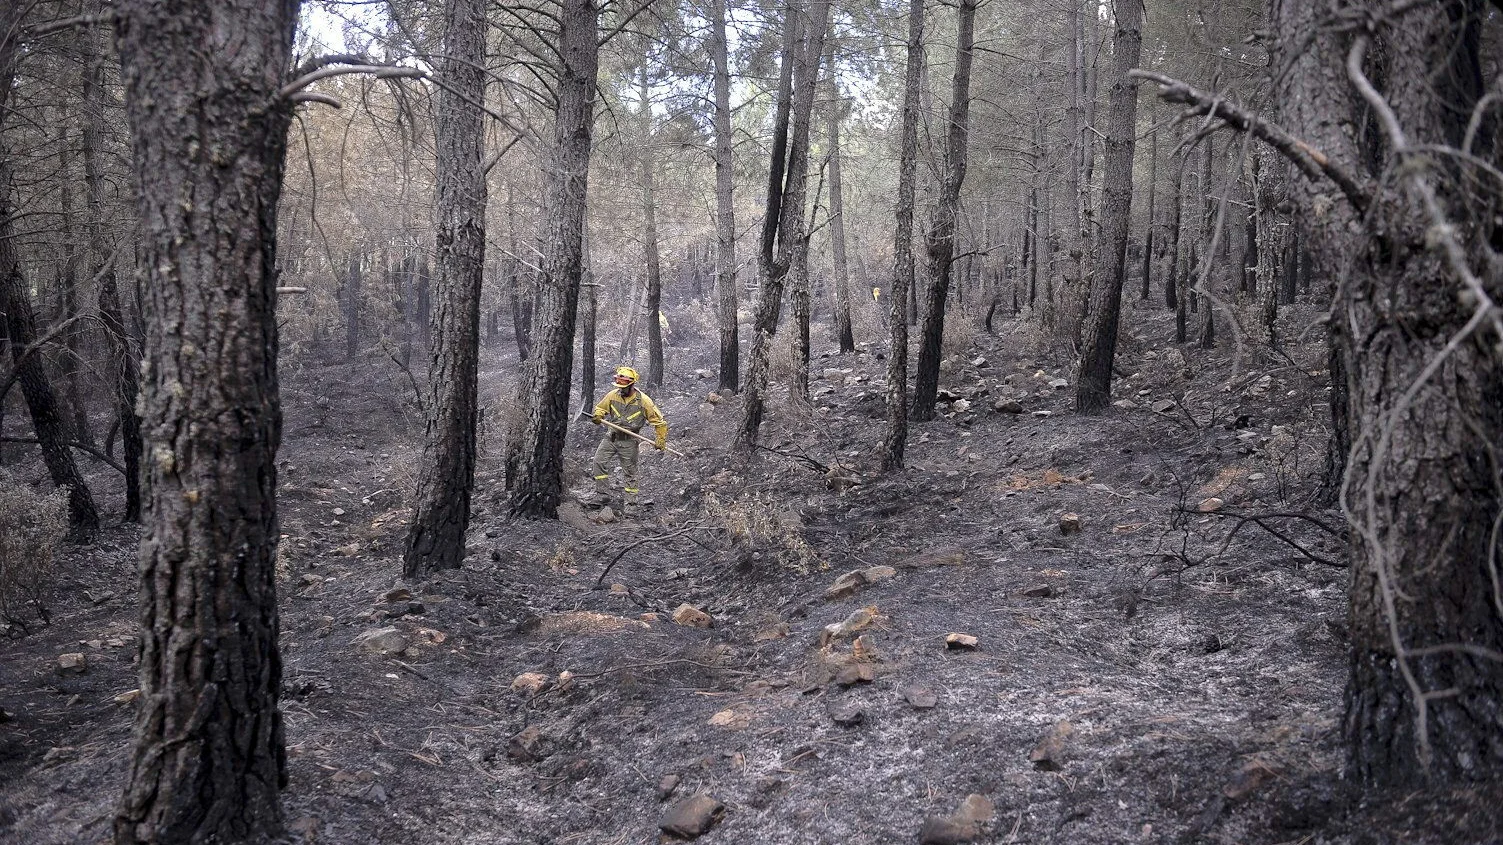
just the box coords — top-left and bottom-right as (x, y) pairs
(1328, 0), (1503, 786)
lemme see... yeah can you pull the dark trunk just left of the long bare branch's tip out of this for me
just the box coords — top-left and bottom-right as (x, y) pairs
(1075, 0), (1142, 413)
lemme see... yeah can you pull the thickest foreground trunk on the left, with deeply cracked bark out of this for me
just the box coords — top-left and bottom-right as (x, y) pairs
(114, 0), (298, 843)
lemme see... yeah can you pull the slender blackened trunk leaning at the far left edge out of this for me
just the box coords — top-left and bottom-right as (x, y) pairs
(0, 21), (99, 531)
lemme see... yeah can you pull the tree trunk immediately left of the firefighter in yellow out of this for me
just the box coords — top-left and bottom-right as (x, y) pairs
(511, 0), (600, 519)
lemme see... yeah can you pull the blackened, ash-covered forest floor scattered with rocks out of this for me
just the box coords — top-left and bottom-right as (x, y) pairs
(0, 299), (1498, 845)
